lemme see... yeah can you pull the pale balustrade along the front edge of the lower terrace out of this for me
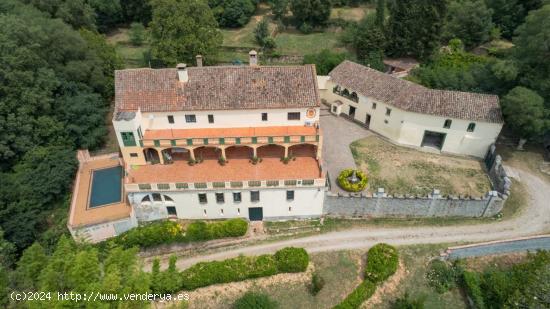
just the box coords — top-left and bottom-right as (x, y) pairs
(124, 178), (325, 192)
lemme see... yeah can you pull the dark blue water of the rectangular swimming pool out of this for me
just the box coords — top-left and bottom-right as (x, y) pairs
(90, 166), (122, 208)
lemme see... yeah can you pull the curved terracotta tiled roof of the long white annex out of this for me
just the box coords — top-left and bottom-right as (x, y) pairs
(329, 61), (503, 123)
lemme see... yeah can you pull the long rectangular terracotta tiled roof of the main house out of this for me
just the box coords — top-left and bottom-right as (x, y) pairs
(115, 65), (320, 112)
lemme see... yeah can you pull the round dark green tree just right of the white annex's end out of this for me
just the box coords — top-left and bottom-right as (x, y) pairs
(502, 86), (550, 149)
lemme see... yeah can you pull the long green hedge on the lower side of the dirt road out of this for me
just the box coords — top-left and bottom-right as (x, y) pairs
(181, 248), (309, 290)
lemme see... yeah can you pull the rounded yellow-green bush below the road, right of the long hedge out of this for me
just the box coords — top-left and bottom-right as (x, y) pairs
(365, 244), (399, 283)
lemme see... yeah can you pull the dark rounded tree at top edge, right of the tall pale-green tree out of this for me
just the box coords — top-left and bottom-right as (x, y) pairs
(208, 0), (257, 28)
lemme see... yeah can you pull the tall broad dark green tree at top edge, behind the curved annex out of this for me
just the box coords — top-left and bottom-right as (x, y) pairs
(387, 0), (447, 59)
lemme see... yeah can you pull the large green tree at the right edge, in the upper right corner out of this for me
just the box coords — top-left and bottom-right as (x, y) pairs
(513, 4), (550, 102)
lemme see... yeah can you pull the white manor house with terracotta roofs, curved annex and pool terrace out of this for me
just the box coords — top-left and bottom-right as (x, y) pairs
(68, 51), (503, 242)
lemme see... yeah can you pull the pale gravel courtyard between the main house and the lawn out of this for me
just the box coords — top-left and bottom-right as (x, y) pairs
(320, 105), (372, 193)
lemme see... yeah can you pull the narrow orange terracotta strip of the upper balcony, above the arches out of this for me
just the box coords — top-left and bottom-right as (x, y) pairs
(143, 126), (317, 140)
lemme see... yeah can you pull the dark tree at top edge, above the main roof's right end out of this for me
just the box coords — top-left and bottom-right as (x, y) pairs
(290, 0), (332, 27)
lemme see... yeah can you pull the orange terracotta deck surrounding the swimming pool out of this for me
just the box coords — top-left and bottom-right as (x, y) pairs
(68, 152), (132, 227)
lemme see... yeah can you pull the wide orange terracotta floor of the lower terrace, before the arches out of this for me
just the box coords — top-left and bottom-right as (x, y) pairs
(129, 157), (321, 183)
